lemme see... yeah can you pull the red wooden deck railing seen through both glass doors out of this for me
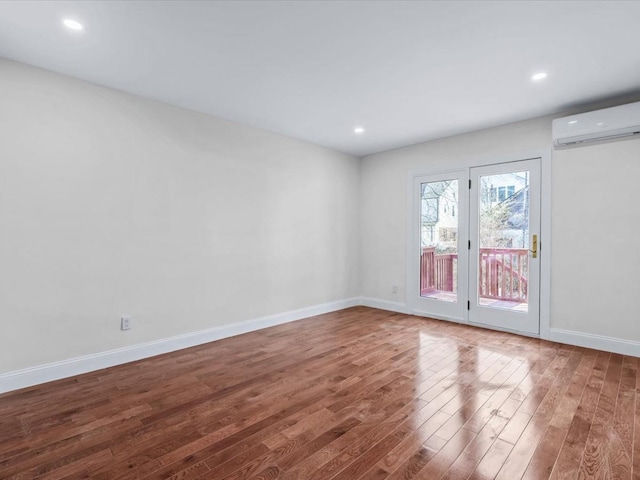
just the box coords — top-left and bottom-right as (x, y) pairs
(420, 247), (529, 302)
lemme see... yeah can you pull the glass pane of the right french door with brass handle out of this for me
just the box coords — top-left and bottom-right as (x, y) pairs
(477, 171), (530, 312)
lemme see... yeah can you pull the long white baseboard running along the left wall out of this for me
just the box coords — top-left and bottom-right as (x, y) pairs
(0, 298), (360, 393)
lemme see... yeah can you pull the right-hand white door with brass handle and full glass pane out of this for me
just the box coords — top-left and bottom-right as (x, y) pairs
(468, 158), (541, 334)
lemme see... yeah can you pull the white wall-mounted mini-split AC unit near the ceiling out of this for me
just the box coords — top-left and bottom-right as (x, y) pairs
(552, 102), (640, 147)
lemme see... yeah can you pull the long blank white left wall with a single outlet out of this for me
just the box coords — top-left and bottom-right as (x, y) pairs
(0, 60), (359, 373)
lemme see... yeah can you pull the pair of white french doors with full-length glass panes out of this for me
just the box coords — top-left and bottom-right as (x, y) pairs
(408, 159), (541, 334)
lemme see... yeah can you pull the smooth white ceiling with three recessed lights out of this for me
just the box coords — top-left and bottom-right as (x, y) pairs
(0, 0), (640, 156)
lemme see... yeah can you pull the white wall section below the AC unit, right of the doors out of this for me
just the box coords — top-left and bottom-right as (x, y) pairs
(552, 139), (640, 341)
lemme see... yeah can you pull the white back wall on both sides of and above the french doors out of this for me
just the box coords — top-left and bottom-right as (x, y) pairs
(360, 116), (640, 346)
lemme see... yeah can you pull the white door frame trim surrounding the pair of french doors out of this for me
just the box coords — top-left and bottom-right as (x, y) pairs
(405, 149), (552, 339)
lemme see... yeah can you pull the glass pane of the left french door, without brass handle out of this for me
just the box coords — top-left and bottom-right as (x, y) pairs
(420, 179), (460, 302)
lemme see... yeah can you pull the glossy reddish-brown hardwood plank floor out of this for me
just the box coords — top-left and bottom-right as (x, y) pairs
(0, 307), (640, 480)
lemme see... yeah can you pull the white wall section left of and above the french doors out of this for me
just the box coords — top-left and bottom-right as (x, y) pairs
(360, 118), (551, 302)
